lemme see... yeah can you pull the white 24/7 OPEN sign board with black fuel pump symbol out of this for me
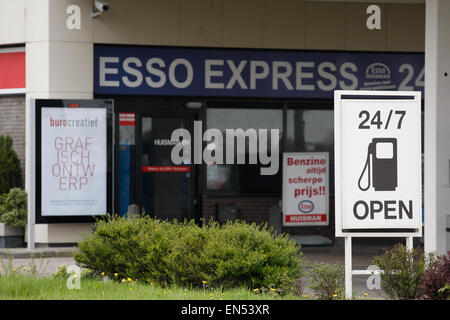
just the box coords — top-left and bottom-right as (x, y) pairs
(335, 91), (422, 235)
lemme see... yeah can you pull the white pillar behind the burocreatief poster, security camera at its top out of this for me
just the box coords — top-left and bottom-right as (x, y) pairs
(25, 0), (94, 248)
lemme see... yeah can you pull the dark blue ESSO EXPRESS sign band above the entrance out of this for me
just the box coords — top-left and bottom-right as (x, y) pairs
(94, 45), (424, 99)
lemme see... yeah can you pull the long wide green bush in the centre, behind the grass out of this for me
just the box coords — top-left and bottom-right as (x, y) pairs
(74, 217), (303, 292)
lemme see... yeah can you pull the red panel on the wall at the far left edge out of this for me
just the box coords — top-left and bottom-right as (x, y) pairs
(0, 51), (25, 89)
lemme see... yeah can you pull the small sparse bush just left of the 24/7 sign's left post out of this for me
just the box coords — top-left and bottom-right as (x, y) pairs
(308, 263), (344, 300)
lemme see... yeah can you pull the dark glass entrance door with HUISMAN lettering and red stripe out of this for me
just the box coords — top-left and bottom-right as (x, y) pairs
(138, 115), (196, 220)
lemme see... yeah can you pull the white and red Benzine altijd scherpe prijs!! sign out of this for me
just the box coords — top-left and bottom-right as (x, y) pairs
(282, 152), (329, 227)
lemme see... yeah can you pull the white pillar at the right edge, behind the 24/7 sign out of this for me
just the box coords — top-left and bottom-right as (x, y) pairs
(424, 0), (450, 253)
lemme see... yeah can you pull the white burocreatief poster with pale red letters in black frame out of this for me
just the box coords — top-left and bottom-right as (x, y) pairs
(41, 107), (107, 216)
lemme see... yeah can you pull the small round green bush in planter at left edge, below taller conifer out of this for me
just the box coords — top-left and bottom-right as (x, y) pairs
(0, 188), (28, 227)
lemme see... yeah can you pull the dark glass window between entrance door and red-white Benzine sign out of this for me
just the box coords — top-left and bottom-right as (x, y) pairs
(206, 108), (283, 193)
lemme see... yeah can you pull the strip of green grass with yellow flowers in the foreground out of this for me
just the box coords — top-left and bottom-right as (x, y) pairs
(0, 272), (301, 300)
